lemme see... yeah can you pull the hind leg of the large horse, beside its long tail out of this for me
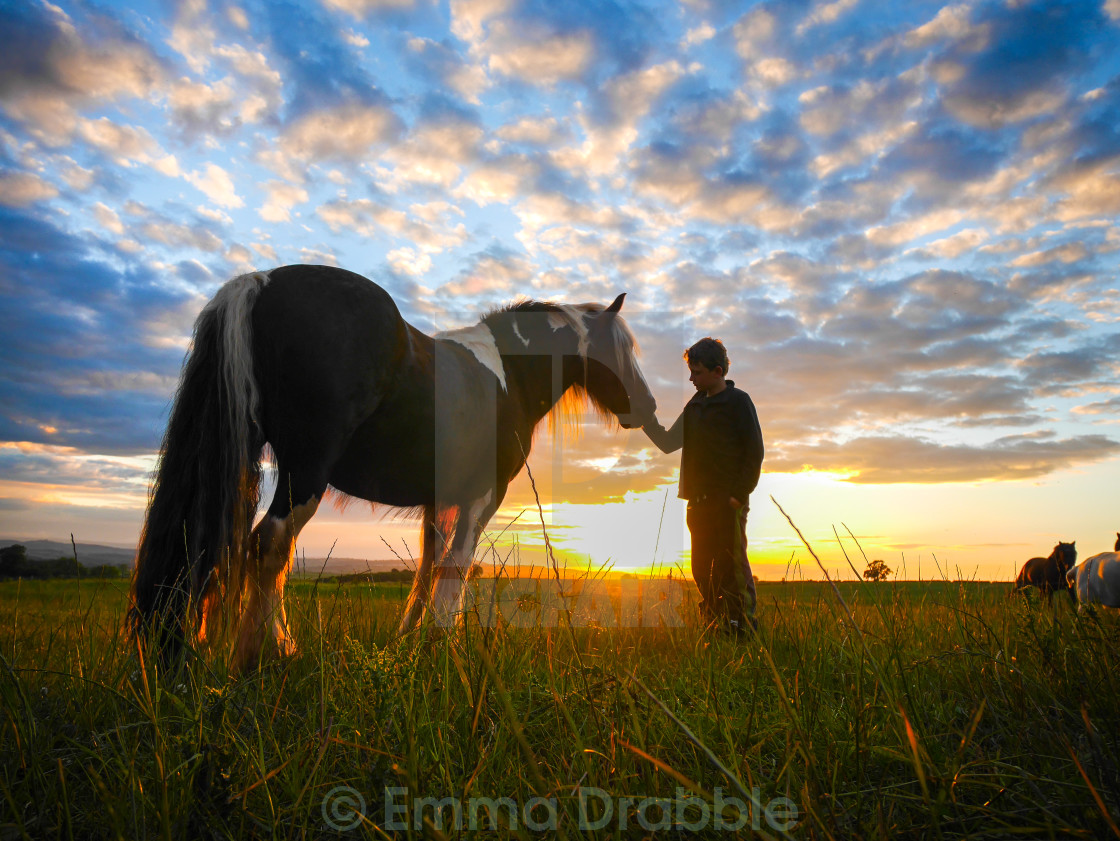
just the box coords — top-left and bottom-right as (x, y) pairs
(234, 473), (326, 670)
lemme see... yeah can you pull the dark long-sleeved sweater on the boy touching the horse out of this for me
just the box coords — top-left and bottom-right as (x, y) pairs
(644, 380), (764, 502)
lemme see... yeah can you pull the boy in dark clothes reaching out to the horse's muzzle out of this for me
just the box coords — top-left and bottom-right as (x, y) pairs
(643, 337), (764, 634)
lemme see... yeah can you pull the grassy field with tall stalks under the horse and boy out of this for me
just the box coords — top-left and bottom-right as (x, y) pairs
(0, 566), (1120, 840)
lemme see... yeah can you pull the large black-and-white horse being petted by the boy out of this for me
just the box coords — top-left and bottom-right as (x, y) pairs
(129, 265), (655, 671)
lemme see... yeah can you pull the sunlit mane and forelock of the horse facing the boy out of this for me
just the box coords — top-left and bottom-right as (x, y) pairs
(480, 299), (638, 440)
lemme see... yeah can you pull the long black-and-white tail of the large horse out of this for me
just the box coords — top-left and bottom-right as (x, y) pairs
(128, 272), (268, 665)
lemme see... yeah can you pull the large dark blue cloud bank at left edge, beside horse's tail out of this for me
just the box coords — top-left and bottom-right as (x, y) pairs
(0, 208), (197, 454)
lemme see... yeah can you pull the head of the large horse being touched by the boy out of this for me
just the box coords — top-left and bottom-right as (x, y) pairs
(584, 292), (657, 429)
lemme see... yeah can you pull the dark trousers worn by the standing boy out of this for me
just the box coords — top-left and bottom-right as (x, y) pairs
(688, 496), (755, 627)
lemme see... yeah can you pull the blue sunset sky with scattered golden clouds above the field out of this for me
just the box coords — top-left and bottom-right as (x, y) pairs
(0, 0), (1120, 579)
